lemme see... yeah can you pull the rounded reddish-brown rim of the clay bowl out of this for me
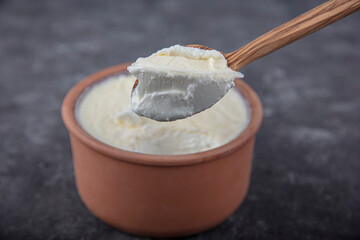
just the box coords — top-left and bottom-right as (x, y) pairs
(61, 63), (263, 166)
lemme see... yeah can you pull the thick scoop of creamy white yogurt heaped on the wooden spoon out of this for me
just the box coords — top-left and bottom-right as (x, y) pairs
(128, 45), (243, 121)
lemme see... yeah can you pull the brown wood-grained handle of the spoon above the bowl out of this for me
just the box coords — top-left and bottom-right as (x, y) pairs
(224, 0), (360, 71)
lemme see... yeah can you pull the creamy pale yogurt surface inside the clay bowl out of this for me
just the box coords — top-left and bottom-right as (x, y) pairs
(75, 74), (250, 155)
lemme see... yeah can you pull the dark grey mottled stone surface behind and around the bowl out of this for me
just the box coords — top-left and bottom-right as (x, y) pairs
(0, 0), (360, 240)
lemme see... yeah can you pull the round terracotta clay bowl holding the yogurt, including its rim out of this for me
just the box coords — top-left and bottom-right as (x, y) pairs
(62, 64), (262, 237)
